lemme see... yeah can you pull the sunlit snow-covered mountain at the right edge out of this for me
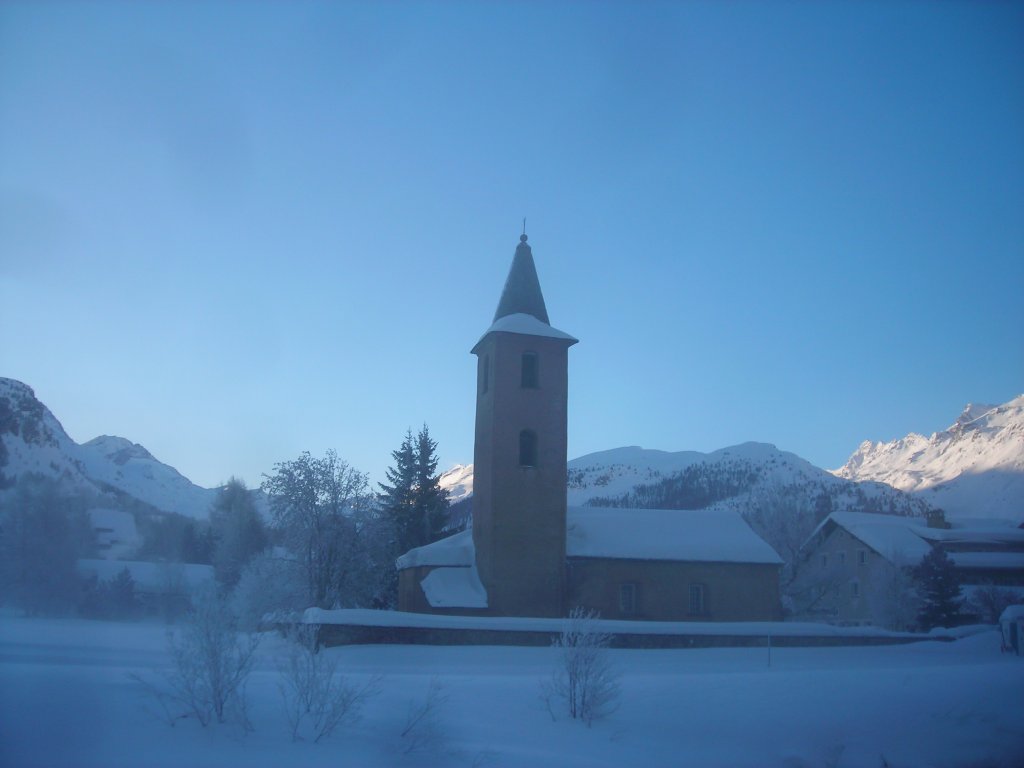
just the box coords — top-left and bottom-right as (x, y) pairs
(834, 395), (1024, 522)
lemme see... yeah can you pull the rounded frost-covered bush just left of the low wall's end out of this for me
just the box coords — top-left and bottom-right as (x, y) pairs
(231, 551), (312, 631)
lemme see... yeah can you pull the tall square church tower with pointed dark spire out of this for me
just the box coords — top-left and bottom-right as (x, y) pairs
(472, 234), (577, 616)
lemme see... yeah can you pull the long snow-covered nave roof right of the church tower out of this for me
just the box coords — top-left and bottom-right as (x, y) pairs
(565, 507), (782, 565)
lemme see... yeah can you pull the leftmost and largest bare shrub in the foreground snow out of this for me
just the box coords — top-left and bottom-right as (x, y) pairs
(161, 586), (259, 728)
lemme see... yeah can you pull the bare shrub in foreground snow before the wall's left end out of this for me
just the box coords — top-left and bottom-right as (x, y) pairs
(279, 625), (380, 743)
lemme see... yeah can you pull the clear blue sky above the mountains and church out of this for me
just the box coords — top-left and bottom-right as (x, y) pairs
(0, 2), (1024, 485)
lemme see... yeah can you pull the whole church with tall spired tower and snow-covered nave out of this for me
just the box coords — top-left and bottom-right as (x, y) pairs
(397, 234), (781, 621)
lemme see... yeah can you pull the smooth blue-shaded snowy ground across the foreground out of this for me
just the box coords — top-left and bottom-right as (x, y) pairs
(0, 614), (1024, 768)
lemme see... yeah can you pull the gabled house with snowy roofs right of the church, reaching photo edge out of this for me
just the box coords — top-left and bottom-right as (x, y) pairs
(798, 512), (1024, 626)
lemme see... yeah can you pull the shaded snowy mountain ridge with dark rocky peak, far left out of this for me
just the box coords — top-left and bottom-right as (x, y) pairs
(0, 377), (217, 518)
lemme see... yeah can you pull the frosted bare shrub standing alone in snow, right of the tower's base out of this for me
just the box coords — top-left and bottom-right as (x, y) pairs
(541, 607), (620, 727)
